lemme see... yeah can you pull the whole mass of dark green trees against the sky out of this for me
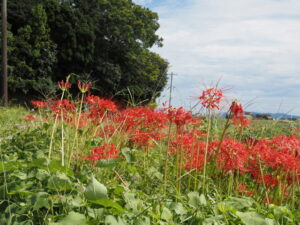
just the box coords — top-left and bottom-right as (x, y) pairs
(8, 0), (168, 102)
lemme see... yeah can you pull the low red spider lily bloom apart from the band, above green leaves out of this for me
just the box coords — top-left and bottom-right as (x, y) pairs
(83, 144), (120, 162)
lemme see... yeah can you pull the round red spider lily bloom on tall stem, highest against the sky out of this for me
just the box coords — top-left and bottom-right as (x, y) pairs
(199, 88), (223, 109)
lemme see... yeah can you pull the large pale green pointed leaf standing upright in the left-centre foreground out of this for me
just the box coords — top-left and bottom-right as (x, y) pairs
(84, 176), (107, 200)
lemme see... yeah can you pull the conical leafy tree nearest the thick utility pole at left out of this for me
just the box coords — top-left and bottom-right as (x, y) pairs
(9, 4), (56, 95)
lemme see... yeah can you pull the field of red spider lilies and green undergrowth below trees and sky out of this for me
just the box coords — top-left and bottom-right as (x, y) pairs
(0, 81), (300, 225)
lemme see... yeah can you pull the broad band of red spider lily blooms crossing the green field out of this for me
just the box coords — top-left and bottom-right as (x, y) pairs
(28, 82), (300, 202)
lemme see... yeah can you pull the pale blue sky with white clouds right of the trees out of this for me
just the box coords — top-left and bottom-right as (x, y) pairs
(134, 0), (300, 115)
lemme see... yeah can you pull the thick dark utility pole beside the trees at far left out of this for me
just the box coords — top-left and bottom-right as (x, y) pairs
(1, 0), (8, 106)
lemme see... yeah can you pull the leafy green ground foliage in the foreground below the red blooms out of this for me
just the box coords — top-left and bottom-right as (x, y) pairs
(0, 108), (300, 225)
